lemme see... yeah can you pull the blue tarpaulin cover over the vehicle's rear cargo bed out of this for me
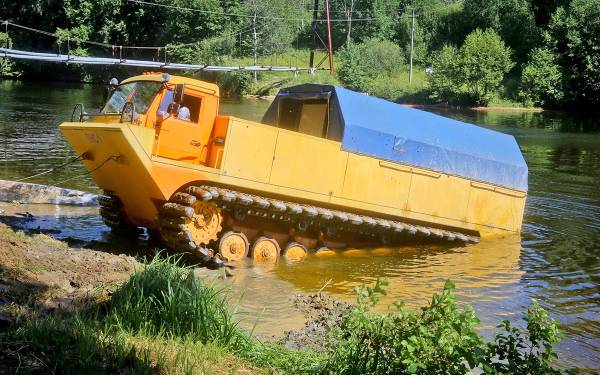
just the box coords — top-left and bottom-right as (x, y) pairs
(263, 85), (528, 191)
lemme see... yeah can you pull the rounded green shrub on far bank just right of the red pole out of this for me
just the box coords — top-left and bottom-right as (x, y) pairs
(337, 38), (404, 92)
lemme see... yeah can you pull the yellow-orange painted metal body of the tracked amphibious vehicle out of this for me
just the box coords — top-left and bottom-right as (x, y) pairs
(60, 74), (527, 236)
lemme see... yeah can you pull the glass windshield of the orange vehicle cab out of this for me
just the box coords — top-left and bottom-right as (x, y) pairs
(102, 81), (162, 115)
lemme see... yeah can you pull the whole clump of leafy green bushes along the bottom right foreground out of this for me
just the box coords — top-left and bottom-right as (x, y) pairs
(321, 280), (575, 375)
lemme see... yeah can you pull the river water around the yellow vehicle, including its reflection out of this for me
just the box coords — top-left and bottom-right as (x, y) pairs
(0, 81), (600, 372)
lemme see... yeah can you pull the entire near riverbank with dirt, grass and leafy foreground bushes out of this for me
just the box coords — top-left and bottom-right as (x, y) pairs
(0, 225), (576, 374)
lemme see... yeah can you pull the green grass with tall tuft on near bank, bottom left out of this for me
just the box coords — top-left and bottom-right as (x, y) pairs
(9, 255), (319, 374)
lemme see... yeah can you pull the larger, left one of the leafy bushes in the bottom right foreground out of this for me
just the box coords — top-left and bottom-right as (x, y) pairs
(325, 281), (482, 374)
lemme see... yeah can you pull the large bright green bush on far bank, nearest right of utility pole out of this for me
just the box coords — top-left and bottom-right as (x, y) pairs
(429, 30), (513, 105)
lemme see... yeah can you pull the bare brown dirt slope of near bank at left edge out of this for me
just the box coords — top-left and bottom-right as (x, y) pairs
(0, 224), (138, 324)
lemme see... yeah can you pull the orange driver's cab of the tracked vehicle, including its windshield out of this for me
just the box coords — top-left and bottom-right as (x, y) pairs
(90, 73), (226, 167)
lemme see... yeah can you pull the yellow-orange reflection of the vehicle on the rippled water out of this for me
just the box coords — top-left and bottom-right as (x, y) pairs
(273, 235), (526, 311)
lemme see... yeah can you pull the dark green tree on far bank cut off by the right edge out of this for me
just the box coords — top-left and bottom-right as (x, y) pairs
(545, 0), (600, 107)
